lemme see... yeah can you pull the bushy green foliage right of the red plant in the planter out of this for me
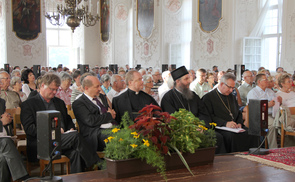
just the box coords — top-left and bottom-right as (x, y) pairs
(169, 109), (216, 153)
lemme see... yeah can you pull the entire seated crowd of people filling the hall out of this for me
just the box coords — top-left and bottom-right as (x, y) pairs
(0, 65), (295, 181)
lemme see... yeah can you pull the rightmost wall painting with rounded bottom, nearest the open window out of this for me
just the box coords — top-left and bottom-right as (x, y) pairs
(198, 0), (222, 32)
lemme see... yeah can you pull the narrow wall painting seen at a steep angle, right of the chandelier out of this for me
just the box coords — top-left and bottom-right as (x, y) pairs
(100, 0), (110, 42)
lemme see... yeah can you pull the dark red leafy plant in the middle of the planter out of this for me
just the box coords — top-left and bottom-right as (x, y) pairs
(129, 104), (176, 154)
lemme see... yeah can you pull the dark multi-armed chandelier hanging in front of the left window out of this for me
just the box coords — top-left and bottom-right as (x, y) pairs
(45, 0), (100, 33)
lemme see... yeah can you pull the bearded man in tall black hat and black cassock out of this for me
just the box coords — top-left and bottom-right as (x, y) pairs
(161, 66), (226, 153)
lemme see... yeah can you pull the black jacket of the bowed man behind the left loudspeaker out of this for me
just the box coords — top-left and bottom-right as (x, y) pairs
(21, 94), (75, 162)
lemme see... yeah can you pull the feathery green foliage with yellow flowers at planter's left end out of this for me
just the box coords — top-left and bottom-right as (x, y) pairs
(104, 112), (166, 179)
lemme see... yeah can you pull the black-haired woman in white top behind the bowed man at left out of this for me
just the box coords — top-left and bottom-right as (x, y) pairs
(21, 69), (37, 96)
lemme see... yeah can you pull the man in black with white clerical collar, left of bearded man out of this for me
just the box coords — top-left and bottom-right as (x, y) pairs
(112, 70), (158, 123)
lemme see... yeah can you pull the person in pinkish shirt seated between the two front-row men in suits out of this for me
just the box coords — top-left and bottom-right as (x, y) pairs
(55, 72), (72, 105)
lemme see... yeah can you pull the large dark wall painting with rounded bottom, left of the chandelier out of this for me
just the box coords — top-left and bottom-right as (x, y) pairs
(12, 0), (41, 40)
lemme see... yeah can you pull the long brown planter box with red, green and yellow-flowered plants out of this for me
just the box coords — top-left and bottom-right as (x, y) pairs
(104, 105), (216, 179)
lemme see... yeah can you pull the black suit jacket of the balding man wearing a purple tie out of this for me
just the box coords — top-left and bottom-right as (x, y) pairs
(72, 94), (113, 149)
